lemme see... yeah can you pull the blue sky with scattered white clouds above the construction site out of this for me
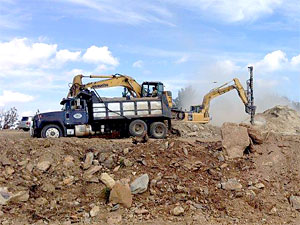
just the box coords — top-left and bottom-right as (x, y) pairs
(0, 0), (300, 115)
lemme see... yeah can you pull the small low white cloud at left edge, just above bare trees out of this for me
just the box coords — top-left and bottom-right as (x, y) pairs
(0, 90), (34, 106)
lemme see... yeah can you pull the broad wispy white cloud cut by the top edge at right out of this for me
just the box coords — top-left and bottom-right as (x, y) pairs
(167, 0), (283, 22)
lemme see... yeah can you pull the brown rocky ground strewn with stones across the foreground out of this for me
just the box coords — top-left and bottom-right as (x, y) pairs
(0, 106), (300, 225)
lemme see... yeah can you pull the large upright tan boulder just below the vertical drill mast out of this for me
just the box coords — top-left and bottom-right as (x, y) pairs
(221, 123), (250, 159)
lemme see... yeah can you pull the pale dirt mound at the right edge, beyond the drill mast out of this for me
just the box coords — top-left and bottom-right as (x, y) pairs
(255, 106), (300, 135)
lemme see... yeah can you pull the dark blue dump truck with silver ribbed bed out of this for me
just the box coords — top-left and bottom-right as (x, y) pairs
(30, 87), (172, 139)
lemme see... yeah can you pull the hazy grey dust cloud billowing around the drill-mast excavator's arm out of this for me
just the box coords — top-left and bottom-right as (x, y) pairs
(175, 62), (292, 126)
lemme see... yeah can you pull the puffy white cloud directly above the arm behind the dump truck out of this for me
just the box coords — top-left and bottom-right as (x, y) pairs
(82, 45), (119, 66)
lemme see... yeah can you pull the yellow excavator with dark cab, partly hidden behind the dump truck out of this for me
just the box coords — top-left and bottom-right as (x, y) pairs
(67, 74), (173, 108)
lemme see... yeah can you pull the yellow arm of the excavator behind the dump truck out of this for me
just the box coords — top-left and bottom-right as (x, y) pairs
(68, 74), (142, 97)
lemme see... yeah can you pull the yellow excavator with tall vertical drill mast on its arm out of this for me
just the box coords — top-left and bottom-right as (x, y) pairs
(173, 67), (256, 124)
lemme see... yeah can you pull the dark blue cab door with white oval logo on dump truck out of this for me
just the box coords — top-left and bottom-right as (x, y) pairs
(65, 98), (89, 125)
